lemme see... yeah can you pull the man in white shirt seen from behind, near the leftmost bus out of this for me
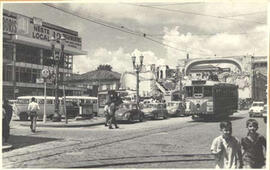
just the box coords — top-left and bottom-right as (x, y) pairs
(28, 97), (40, 132)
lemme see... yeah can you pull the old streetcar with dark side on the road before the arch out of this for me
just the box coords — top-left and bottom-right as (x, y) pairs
(184, 80), (238, 119)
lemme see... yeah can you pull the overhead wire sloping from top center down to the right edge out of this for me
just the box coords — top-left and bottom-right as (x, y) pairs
(123, 3), (266, 24)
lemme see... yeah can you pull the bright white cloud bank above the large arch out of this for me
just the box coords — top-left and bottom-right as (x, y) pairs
(163, 25), (267, 64)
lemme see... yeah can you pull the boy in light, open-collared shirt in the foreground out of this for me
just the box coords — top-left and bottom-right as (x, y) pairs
(211, 121), (243, 169)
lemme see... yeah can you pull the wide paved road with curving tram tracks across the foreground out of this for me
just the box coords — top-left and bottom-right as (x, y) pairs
(3, 111), (266, 168)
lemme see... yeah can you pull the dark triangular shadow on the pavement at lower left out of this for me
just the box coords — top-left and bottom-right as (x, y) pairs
(4, 135), (59, 150)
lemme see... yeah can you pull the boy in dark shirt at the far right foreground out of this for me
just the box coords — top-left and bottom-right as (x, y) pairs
(241, 119), (266, 168)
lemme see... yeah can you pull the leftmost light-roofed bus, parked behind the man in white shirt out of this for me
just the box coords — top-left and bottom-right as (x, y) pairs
(13, 96), (63, 120)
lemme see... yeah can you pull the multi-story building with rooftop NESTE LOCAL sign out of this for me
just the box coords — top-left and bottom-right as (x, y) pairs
(2, 9), (86, 99)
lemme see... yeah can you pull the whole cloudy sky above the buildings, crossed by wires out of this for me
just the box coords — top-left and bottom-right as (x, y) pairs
(3, 1), (268, 74)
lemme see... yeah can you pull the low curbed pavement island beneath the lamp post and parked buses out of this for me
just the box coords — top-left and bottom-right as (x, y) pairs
(20, 117), (105, 128)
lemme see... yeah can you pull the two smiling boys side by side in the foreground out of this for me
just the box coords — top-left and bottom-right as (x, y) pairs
(211, 119), (266, 169)
